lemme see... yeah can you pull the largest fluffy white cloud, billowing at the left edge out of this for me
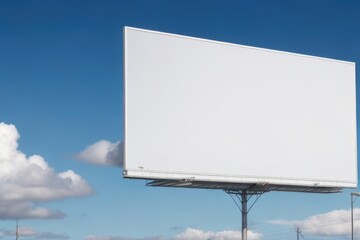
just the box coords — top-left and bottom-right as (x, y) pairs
(0, 123), (93, 219)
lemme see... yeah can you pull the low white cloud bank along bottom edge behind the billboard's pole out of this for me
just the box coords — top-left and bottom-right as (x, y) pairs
(85, 228), (262, 240)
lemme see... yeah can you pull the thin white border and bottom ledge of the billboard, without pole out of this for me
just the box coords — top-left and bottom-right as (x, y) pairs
(123, 27), (357, 193)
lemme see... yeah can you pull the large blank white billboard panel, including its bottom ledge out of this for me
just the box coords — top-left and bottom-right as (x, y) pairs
(124, 27), (357, 187)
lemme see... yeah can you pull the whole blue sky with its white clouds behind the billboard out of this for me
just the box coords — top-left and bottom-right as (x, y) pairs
(0, 0), (360, 240)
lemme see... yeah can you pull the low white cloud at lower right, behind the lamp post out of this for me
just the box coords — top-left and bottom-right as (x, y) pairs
(269, 208), (360, 236)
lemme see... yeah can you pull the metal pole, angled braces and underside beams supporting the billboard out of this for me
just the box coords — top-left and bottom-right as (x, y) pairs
(146, 179), (342, 240)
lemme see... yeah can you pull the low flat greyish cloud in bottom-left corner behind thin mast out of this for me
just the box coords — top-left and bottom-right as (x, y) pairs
(0, 227), (69, 239)
